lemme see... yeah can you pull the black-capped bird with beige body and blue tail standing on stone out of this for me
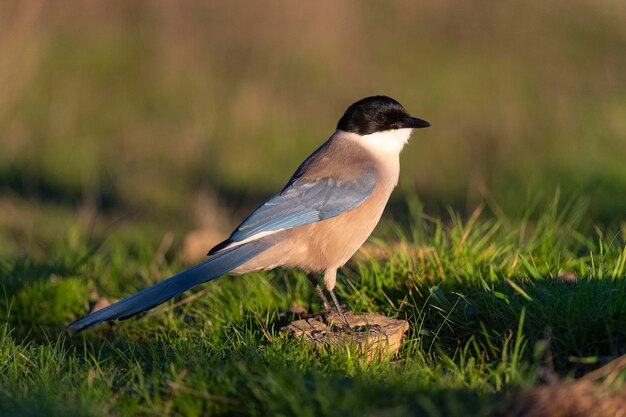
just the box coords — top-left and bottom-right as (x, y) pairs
(68, 95), (430, 332)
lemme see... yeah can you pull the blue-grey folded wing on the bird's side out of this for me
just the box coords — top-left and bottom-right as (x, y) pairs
(209, 166), (376, 255)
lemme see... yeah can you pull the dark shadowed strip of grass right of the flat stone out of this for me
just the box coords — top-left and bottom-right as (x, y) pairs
(364, 268), (626, 376)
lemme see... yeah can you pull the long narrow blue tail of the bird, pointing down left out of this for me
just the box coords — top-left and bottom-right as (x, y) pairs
(67, 241), (269, 332)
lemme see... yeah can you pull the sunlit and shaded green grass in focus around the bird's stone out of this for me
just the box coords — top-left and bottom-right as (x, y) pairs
(0, 199), (626, 416)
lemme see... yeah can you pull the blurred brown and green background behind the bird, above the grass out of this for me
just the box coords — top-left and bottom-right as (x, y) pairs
(0, 0), (626, 254)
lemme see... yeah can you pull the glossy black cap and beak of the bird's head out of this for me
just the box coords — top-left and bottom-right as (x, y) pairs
(337, 96), (430, 135)
